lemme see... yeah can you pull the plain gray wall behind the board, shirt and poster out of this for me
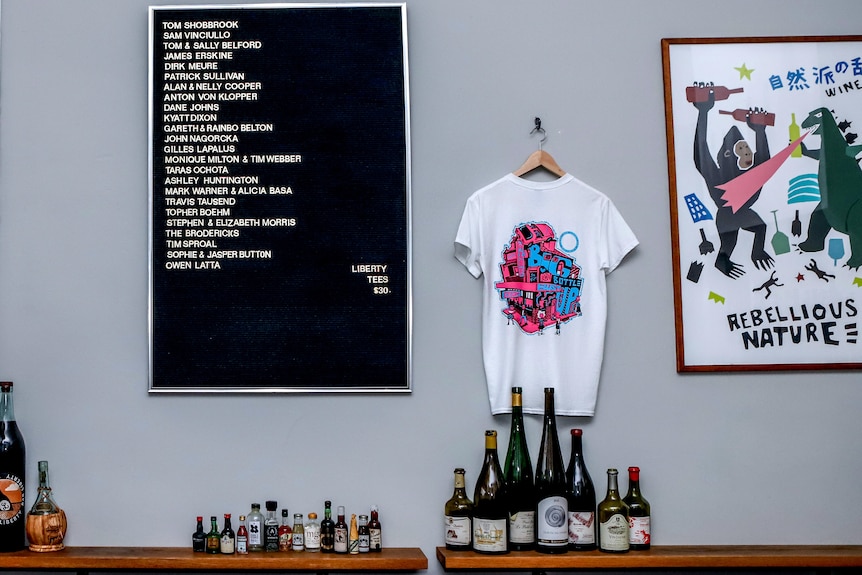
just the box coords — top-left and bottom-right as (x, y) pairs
(0, 0), (862, 572)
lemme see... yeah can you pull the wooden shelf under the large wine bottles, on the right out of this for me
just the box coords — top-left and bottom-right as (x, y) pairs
(437, 545), (862, 571)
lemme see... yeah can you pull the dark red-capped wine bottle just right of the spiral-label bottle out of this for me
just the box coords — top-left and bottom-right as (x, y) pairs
(566, 429), (596, 551)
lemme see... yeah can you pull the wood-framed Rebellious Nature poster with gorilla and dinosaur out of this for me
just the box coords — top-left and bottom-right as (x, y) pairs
(662, 36), (862, 372)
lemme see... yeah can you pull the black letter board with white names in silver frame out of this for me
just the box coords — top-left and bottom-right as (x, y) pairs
(149, 4), (411, 392)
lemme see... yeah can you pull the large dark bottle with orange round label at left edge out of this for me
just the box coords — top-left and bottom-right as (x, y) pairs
(0, 381), (27, 552)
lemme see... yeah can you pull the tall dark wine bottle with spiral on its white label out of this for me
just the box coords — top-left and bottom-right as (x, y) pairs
(536, 387), (569, 553)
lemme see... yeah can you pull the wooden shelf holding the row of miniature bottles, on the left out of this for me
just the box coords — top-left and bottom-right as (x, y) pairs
(0, 547), (428, 573)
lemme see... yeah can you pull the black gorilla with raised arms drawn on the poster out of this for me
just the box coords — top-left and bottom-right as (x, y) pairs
(693, 92), (774, 279)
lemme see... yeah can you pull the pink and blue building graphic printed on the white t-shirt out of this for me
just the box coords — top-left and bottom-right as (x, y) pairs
(494, 222), (584, 335)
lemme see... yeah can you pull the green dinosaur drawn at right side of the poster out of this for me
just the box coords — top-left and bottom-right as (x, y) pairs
(798, 108), (862, 269)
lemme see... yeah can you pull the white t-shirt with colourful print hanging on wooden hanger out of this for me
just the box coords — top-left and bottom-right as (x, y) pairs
(455, 174), (638, 415)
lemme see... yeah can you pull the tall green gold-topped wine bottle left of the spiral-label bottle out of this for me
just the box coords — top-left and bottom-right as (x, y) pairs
(503, 387), (536, 551)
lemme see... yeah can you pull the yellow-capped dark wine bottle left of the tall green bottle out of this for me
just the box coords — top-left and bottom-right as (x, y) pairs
(473, 429), (509, 554)
